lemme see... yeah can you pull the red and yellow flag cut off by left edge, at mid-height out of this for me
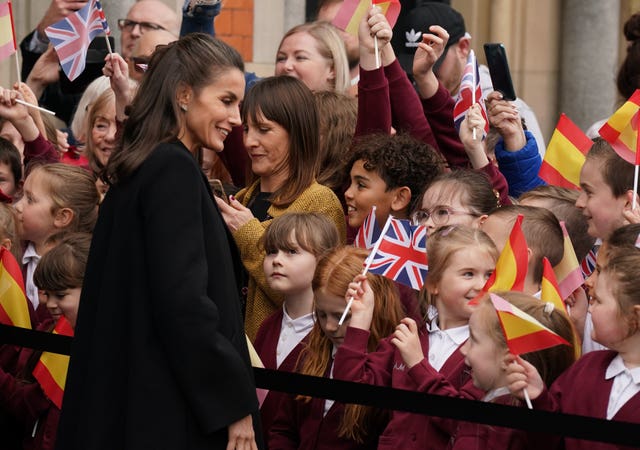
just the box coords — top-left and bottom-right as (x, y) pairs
(0, 247), (31, 328)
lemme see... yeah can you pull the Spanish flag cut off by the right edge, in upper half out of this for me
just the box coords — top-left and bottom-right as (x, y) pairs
(598, 89), (640, 166)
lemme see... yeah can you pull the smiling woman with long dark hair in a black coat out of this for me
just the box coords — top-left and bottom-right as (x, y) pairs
(57, 33), (261, 450)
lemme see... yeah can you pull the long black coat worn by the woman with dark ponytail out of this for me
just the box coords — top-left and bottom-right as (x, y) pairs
(56, 143), (261, 450)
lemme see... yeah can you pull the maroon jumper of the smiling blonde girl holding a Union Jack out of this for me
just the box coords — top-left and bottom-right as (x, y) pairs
(333, 327), (470, 450)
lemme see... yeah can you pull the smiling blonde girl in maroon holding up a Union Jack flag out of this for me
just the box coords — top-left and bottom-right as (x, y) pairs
(334, 226), (498, 450)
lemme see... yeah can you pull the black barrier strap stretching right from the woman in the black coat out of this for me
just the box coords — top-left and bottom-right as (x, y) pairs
(254, 368), (640, 446)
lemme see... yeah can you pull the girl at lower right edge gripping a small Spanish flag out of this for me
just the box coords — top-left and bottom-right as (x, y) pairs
(508, 247), (640, 450)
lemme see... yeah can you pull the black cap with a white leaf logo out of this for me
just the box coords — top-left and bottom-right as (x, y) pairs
(391, 2), (467, 74)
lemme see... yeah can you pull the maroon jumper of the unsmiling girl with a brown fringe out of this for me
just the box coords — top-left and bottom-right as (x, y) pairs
(254, 308), (308, 442)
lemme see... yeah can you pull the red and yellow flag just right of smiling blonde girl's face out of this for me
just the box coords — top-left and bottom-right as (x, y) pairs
(483, 214), (529, 292)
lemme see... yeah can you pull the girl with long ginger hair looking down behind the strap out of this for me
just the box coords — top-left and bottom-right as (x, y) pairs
(269, 246), (402, 450)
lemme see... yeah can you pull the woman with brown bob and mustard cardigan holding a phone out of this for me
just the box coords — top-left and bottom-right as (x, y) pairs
(216, 76), (346, 339)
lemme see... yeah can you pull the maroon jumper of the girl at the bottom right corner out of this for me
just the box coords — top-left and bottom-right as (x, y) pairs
(533, 350), (640, 450)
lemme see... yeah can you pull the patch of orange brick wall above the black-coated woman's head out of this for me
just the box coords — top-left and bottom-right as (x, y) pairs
(215, 0), (253, 61)
